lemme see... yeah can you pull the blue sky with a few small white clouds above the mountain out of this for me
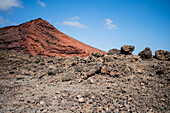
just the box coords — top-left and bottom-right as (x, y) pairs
(0, 0), (170, 54)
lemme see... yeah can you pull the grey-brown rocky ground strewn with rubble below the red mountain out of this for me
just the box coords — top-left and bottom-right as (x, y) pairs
(0, 51), (170, 113)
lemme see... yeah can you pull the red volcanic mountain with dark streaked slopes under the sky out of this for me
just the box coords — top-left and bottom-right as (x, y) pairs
(0, 18), (106, 57)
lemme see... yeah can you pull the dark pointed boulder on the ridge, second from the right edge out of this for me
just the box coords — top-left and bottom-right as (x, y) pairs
(138, 47), (152, 59)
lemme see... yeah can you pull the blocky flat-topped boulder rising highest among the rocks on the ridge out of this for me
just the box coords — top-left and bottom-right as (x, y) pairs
(121, 45), (135, 55)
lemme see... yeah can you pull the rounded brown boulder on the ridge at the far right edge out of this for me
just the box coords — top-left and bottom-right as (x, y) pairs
(155, 50), (170, 60)
